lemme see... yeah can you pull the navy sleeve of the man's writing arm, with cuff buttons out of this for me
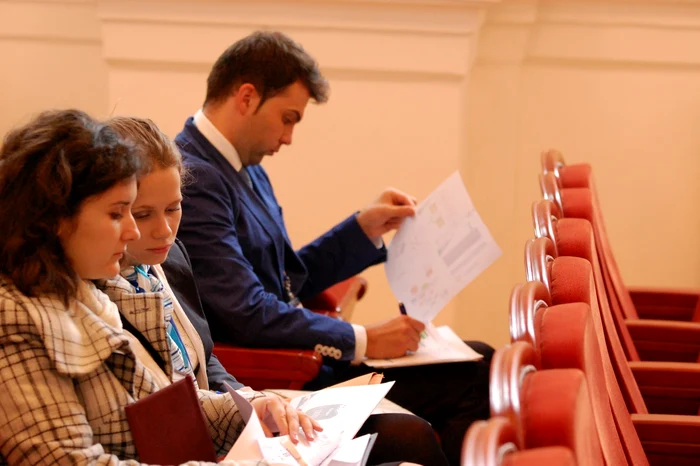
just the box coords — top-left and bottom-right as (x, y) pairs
(179, 163), (355, 360)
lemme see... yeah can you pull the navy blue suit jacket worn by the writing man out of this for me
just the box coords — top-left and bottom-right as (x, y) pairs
(175, 118), (386, 360)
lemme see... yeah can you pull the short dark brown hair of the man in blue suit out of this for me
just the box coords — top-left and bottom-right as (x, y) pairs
(204, 31), (328, 108)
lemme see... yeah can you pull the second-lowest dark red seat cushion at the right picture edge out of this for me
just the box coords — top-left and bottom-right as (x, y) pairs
(629, 361), (700, 416)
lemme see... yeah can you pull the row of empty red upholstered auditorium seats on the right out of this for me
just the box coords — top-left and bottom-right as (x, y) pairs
(463, 151), (700, 466)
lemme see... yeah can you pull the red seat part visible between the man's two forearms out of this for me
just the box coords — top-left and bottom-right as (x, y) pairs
(304, 276), (367, 322)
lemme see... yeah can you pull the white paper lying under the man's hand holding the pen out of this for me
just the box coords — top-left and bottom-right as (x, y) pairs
(364, 324), (483, 369)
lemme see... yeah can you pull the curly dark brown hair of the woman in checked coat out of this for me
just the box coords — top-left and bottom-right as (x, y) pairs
(0, 110), (141, 305)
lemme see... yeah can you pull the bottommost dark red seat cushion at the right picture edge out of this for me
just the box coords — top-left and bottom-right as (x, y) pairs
(632, 414), (700, 465)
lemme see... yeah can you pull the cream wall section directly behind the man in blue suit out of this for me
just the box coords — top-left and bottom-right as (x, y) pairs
(95, 0), (483, 332)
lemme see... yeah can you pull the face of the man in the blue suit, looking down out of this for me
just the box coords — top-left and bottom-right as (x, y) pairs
(236, 81), (310, 166)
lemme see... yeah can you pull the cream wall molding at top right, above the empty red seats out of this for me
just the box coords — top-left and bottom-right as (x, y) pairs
(477, 0), (700, 68)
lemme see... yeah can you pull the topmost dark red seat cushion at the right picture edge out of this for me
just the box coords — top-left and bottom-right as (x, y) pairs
(628, 287), (700, 321)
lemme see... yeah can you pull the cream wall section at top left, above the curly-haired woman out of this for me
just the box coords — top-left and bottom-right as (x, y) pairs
(0, 0), (107, 134)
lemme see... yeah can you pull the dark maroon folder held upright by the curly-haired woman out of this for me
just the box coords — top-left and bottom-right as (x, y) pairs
(125, 376), (216, 465)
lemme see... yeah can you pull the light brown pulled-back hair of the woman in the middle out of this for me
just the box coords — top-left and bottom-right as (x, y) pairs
(107, 116), (186, 181)
